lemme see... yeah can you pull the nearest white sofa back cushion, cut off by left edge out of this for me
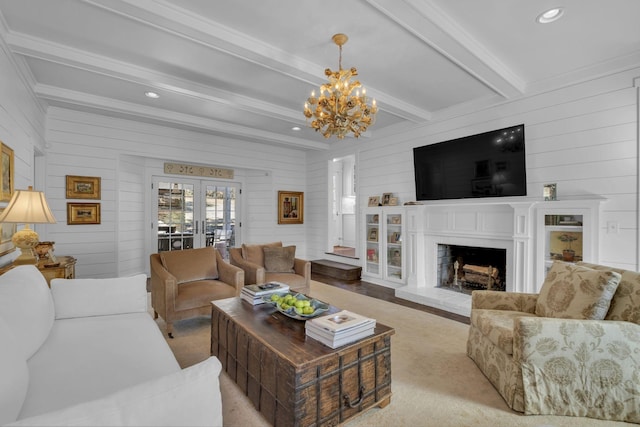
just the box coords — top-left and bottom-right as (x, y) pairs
(0, 318), (29, 425)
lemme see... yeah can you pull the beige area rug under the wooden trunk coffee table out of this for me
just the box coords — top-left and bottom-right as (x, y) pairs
(152, 282), (630, 427)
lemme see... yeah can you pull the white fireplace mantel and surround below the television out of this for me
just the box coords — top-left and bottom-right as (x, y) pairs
(396, 198), (605, 315)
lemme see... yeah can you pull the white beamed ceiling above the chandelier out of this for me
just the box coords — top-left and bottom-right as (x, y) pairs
(0, 0), (640, 150)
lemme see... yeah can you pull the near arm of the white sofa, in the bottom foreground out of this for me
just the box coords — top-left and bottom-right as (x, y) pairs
(6, 357), (222, 426)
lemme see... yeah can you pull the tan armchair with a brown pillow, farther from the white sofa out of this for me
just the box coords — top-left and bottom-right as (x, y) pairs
(229, 242), (311, 293)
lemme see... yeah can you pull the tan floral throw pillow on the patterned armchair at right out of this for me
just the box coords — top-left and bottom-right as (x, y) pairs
(536, 261), (621, 320)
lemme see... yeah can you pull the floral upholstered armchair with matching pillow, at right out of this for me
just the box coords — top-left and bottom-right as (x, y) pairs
(467, 261), (640, 423)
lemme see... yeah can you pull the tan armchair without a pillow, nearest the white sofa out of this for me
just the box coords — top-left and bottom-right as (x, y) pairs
(150, 246), (244, 338)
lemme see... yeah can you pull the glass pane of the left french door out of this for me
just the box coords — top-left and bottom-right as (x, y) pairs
(157, 182), (194, 252)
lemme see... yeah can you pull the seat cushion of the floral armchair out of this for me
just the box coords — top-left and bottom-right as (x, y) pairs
(471, 309), (536, 354)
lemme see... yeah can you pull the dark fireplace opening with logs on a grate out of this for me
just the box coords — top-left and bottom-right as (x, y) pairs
(437, 244), (507, 294)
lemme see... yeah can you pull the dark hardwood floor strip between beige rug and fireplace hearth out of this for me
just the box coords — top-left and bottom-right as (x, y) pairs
(311, 273), (469, 325)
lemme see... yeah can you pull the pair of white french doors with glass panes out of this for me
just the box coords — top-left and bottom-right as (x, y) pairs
(152, 177), (240, 258)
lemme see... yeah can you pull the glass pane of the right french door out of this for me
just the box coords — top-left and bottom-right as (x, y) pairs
(205, 185), (236, 258)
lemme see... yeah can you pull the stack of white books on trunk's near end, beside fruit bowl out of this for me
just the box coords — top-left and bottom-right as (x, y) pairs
(305, 310), (376, 348)
